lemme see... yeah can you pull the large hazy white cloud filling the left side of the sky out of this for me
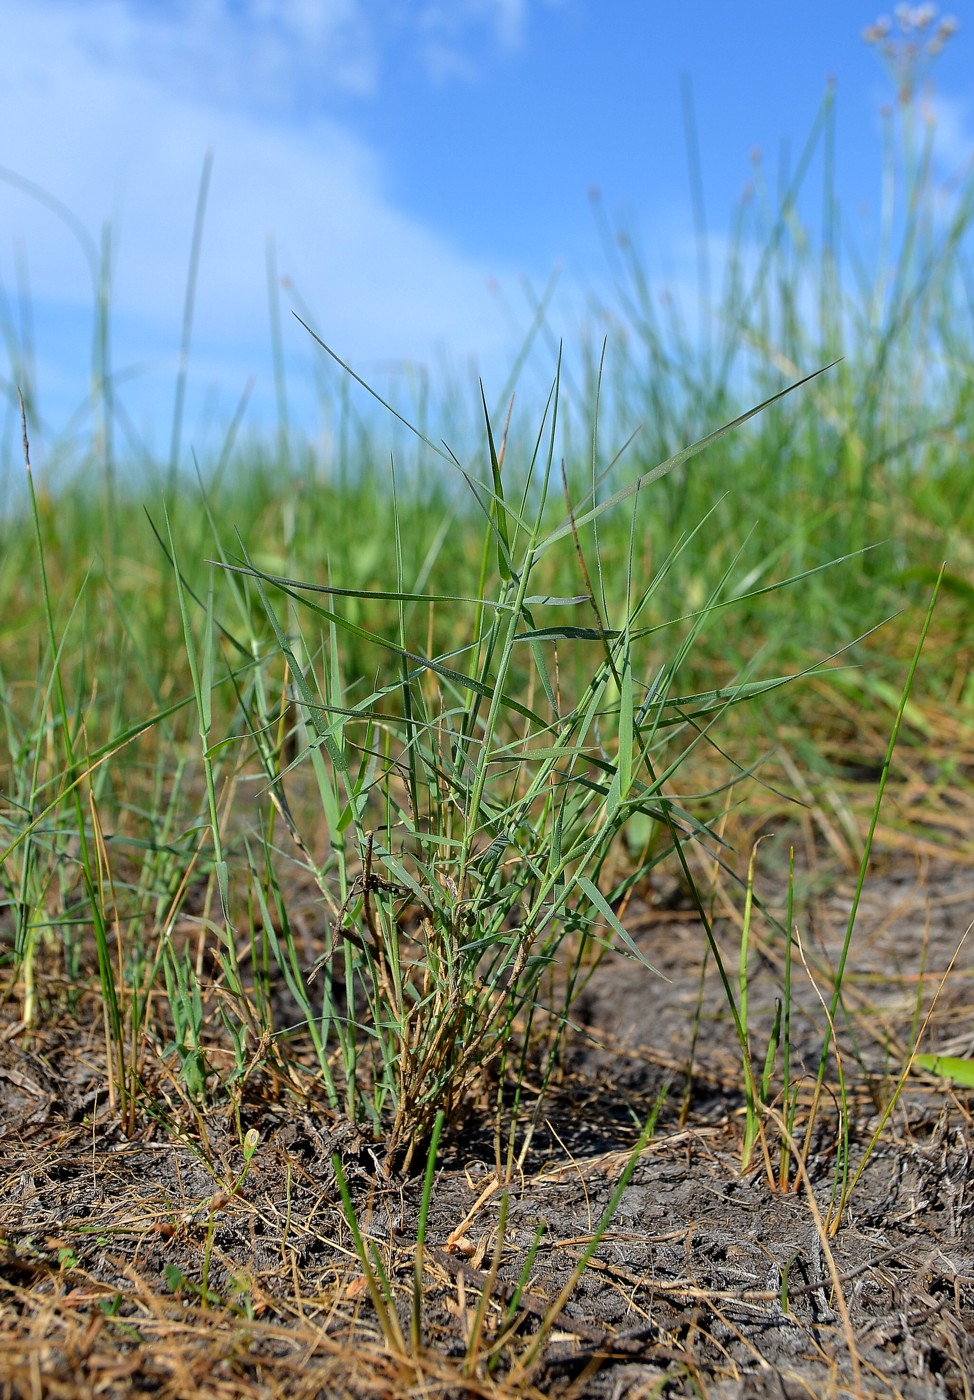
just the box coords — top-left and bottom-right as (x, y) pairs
(0, 0), (562, 459)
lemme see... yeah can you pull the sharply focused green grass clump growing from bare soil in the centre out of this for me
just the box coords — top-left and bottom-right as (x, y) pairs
(197, 352), (850, 1169)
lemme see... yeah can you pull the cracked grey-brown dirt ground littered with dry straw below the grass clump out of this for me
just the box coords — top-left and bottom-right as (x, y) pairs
(0, 840), (974, 1400)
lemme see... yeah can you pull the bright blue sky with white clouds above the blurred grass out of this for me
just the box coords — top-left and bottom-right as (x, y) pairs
(0, 0), (974, 470)
